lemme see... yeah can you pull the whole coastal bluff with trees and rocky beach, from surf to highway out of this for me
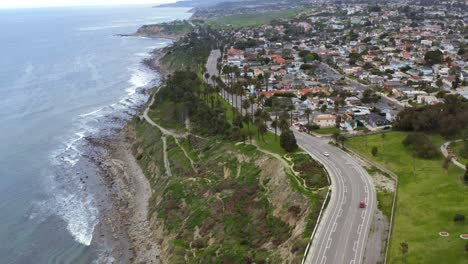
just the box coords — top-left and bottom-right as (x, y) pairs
(99, 24), (327, 263)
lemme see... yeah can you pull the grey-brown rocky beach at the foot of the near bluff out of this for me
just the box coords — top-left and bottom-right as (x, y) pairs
(94, 124), (159, 263)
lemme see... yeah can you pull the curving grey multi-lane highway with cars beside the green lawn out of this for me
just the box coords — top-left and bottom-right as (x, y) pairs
(294, 131), (377, 264)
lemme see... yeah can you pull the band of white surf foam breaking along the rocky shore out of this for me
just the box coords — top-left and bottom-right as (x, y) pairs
(43, 49), (157, 250)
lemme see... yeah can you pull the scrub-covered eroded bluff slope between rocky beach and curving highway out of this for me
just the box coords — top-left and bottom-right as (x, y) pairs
(129, 120), (326, 263)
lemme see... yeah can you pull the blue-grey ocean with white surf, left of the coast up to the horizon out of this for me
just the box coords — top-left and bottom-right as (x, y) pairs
(0, 6), (190, 263)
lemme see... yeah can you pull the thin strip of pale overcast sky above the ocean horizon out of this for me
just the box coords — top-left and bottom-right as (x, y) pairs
(0, 0), (175, 8)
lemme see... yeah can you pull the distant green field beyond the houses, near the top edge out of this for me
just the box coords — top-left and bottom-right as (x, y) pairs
(206, 9), (299, 28)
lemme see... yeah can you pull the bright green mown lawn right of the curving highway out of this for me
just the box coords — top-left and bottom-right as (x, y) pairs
(347, 132), (468, 263)
